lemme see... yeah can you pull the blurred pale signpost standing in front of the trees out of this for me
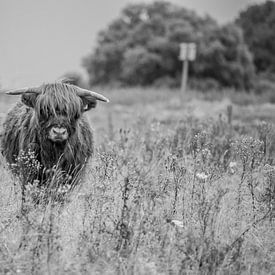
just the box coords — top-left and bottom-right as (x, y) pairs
(179, 43), (197, 96)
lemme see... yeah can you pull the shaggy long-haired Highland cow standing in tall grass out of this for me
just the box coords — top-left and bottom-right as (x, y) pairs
(2, 82), (108, 187)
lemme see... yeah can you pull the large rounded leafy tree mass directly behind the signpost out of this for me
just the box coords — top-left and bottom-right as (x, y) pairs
(84, 1), (253, 88)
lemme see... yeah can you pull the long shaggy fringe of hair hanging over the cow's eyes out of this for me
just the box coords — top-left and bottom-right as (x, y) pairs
(36, 83), (83, 118)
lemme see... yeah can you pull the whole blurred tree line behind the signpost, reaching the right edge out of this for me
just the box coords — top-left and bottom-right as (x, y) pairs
(83, 1), (275, 90)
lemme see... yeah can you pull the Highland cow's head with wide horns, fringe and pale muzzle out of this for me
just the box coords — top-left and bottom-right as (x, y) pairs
(7, 82), (109, 143)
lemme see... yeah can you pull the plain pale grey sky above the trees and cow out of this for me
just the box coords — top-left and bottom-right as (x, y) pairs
(0, 0), (264, 88)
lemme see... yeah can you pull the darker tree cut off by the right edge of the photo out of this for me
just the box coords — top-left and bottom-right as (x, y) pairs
(236, 1), (275, 72)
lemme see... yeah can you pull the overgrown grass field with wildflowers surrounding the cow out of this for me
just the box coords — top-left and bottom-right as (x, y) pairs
(0, 88), (275, 274)
